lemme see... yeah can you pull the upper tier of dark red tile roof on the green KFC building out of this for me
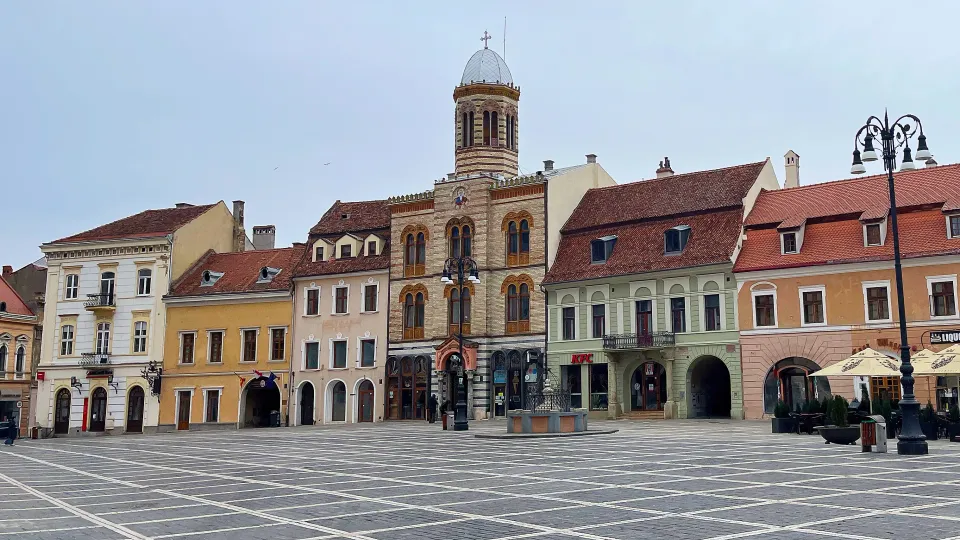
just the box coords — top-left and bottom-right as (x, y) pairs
(562, 161), (766, 232)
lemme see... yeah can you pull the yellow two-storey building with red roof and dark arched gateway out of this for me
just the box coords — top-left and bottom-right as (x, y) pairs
(159, 248), (302, 431)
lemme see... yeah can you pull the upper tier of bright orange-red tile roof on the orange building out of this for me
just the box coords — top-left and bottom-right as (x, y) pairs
(746, 164), (960, 227)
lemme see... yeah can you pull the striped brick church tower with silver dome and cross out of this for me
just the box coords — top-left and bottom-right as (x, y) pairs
(453, 32), (520, 178)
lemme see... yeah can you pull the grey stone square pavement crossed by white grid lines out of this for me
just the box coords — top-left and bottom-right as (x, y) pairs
(0, 421), (960, 540)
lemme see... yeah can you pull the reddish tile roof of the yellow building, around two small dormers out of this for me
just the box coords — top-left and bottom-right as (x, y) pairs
(168, 245), (305, 297)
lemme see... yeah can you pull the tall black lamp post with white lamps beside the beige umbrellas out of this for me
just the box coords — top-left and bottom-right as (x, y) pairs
(850, 111), (933, 455)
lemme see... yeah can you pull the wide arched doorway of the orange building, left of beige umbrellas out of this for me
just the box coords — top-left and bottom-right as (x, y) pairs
(763, 356), (831, 414)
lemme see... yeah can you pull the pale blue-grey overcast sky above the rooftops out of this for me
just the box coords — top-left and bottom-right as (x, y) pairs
(0, 0), (960, 267)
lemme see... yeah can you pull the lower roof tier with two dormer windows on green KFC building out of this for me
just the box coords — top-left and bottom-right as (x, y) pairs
(544, 208), (743, 284)
